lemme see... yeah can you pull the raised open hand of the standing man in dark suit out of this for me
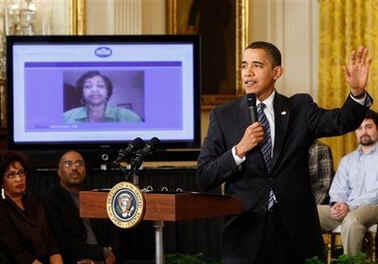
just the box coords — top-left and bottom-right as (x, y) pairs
(344, 47), (371, 97)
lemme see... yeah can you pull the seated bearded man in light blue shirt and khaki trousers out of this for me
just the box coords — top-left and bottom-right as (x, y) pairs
(318, 110), (378, 256)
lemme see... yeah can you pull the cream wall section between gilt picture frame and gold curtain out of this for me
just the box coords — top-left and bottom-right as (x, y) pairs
(250, 0), (319, 99)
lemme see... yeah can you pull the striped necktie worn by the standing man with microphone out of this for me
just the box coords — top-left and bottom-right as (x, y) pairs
(257, 103), (277, 210)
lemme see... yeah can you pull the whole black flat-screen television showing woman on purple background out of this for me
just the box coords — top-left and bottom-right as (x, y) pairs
(7, 35), (200, 153)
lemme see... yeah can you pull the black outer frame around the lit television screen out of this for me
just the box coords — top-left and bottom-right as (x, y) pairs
(6, 35), (201, 155)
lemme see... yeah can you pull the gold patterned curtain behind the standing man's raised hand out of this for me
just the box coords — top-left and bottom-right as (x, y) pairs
(318, 0), (378, 169)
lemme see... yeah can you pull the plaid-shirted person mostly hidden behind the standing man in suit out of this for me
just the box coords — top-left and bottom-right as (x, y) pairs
(308, 140), (334, 204)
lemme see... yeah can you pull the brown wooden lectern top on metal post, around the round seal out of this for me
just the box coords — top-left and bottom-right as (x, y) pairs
(79, 191), (242, 264)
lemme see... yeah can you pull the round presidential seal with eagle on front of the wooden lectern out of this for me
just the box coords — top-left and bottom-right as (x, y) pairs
(106, 182), (145, 228)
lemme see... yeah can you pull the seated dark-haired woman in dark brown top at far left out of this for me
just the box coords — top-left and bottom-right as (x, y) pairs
(0, 152), (63, 264)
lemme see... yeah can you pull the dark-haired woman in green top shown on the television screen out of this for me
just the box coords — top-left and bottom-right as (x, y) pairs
(63, 71), (142, 123)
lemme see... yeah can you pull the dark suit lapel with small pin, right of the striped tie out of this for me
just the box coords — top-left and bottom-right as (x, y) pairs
(272, 93), (290, 168)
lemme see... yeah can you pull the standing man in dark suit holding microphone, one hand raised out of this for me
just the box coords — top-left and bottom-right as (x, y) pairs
(198, 42), (372, 264)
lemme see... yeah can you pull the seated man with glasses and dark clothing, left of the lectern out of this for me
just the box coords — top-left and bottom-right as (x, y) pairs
(46, 151), (115, 264)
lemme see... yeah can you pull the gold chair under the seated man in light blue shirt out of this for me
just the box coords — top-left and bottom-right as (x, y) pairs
(323, 224), (378, 264)
